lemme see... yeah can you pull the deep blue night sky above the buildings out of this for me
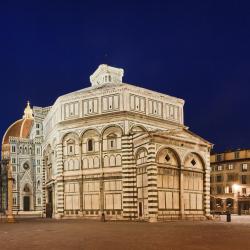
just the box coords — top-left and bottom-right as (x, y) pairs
(0, 0), (250, 151)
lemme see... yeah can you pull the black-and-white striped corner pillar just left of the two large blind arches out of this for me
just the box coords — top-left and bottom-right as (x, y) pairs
(147, 143), (158, 222)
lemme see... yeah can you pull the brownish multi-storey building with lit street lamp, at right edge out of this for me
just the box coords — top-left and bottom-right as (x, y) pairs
(211, 149), (250, 214)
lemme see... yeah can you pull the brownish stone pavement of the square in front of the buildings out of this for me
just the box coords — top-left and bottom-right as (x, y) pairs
(0, 216), (250, 250)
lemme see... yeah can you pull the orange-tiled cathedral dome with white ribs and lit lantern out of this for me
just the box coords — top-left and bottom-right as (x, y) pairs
(2, 102), (33, 144)
